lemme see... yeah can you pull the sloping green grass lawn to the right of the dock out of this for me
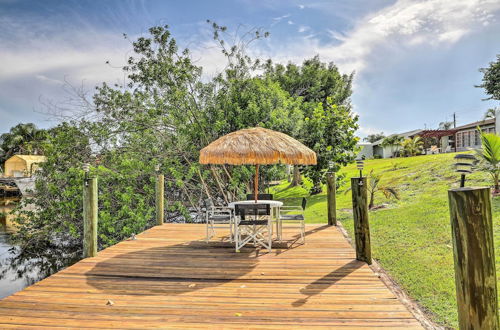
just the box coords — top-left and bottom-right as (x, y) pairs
(273, 154), (500, 327)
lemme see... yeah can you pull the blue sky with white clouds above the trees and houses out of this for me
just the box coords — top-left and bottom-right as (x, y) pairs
(0, 0), (500, 137)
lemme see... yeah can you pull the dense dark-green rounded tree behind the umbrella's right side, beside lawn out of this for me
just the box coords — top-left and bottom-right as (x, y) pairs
(265, 56), (358, 194)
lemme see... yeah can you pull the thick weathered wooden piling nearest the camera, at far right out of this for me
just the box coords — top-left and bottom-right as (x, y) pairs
(448, 187), (500, 330)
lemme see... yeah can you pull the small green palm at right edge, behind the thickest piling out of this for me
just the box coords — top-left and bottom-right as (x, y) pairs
(476, 127), (500, 193)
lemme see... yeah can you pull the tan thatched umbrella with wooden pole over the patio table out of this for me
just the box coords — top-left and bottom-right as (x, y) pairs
(200, 127), (316, 202)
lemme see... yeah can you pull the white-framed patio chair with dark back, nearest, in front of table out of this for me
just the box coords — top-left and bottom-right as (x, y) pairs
(234, 203), (272, 252)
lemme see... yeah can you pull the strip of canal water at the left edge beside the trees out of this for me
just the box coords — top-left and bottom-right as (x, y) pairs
(0, 198), (33, 299)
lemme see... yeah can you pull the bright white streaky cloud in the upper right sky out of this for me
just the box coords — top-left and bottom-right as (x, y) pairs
(258, 0), (500, 76)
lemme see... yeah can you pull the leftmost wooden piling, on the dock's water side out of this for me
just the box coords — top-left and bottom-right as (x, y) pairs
(83, 178), (98, 258)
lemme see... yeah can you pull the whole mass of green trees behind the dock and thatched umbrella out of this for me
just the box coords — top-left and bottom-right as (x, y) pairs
(4, 22), (357, 284)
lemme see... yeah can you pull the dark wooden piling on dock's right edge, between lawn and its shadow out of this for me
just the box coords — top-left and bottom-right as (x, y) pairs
(351, 177), (372, 265)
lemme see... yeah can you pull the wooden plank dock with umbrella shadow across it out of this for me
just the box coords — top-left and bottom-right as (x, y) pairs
(0, 224), (422, 329)
